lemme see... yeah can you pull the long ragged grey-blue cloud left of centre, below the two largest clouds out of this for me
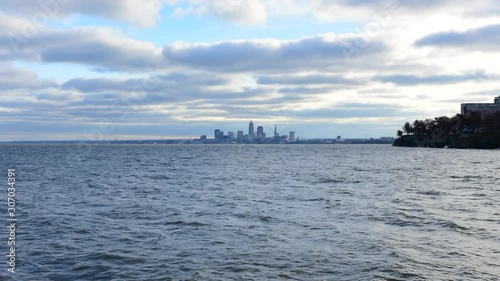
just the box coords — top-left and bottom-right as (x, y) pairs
(61, 73), (278, 109)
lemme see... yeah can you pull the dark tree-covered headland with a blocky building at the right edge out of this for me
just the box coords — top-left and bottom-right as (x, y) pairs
(393, 97), (500, 149)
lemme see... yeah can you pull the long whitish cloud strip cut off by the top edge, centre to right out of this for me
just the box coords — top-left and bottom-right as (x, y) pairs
(171, 0), (472, 25)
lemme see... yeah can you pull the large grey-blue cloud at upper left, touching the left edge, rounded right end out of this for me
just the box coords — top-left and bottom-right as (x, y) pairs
(0, 13), (164, 72)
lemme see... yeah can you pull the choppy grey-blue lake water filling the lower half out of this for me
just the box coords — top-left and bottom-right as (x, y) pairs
(0, 145), (500, 280)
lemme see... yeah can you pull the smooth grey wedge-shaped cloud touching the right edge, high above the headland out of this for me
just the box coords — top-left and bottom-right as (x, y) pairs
(415, 25), (500, 52)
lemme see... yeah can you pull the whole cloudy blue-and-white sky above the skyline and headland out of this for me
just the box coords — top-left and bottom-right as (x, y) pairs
(0, 0), (500, 141)
